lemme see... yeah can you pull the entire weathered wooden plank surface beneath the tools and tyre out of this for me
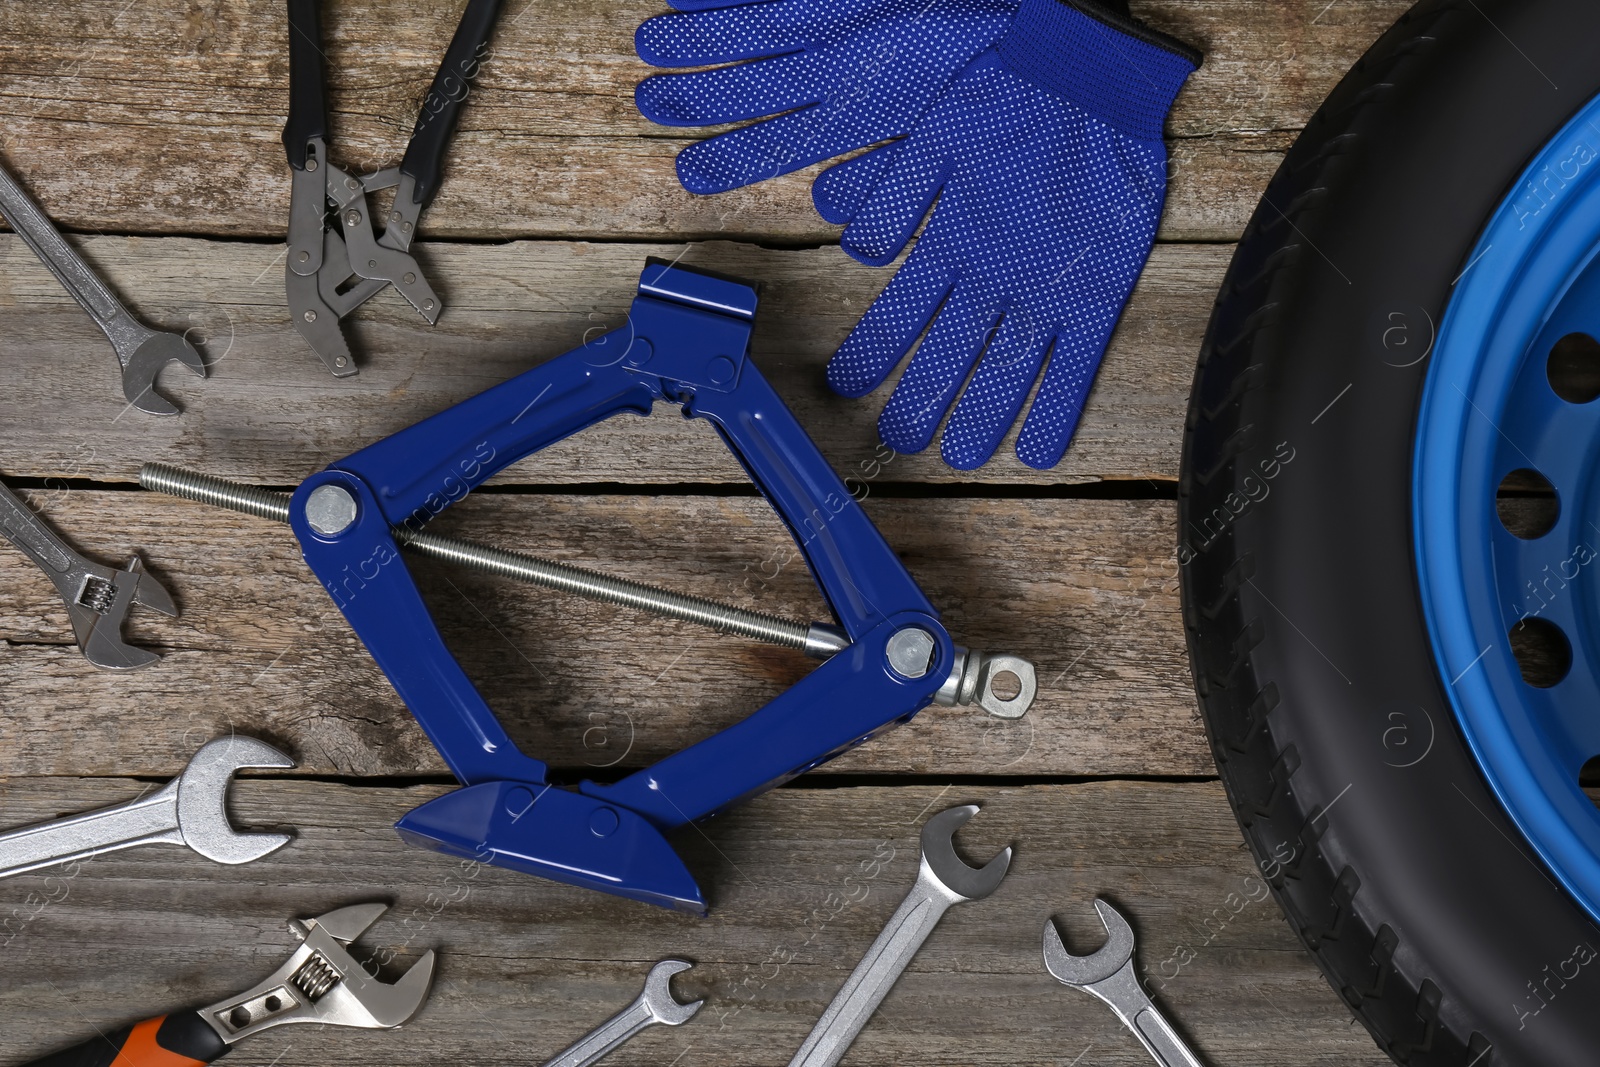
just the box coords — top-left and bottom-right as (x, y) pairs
(0, 0), (1406, 1067)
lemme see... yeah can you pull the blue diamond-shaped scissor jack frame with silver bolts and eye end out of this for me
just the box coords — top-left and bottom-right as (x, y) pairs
(265, 259), (1034, 913)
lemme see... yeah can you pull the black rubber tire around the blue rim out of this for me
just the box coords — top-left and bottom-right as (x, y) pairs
(1179, 0), (1600, 1067)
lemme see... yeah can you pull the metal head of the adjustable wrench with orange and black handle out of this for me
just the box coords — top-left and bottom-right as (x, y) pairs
(200, 904), (435, 1045)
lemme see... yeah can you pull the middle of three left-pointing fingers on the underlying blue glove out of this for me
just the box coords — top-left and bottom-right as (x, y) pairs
(634, 53), (827, 126)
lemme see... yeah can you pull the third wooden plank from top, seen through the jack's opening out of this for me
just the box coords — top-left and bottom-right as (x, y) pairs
(0, 490), (1213, 776)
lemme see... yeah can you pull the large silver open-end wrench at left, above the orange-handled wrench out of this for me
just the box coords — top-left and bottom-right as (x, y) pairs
(0, 737), (294, 878)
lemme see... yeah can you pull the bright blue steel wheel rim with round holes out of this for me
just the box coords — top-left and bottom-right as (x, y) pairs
(1411, 98), (1600, 920)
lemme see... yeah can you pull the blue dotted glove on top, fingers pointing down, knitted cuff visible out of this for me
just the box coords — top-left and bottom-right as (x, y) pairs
(813, 0), (1200, 470)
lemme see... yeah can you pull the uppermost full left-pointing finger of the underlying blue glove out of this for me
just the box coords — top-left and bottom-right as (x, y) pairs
(634, 0), (814, 67)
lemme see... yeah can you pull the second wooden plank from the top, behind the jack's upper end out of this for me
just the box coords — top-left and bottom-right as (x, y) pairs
(0, 235), (1230, 485)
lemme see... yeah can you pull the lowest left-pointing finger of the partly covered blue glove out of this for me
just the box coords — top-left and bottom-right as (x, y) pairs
(677, 106), (889, 194)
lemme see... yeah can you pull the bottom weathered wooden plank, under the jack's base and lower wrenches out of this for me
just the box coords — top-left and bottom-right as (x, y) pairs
(0, 779), (1387, 1067)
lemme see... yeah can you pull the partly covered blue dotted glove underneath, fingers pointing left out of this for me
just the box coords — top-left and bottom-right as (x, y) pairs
(634, 0), (1016, 194)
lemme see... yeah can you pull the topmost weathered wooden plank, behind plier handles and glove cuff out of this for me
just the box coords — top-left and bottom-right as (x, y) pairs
(0, 0), (1408, 243)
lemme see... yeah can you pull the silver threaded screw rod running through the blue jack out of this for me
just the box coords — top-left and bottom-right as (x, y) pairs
(139, 462), (850, 659)
